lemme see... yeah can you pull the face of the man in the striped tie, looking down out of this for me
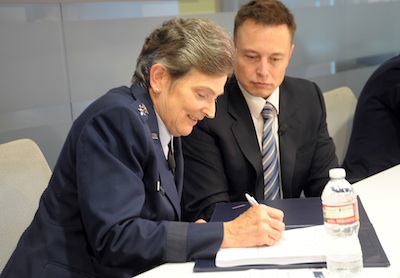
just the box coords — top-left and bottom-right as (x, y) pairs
(235, 20), (294, 98)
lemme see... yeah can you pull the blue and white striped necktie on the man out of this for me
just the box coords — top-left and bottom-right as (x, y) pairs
(261, 102), (280, 200)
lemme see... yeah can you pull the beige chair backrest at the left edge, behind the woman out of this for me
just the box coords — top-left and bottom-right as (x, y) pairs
(0, 139), (51, 273)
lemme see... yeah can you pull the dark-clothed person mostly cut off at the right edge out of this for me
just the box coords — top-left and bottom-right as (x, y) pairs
(343, 53), (400, 181)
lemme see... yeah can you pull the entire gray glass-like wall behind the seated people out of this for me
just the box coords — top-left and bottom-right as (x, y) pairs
(0, 0), (400, 167)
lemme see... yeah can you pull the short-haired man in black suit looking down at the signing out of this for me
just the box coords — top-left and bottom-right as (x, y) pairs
(182, 0), (338, 220)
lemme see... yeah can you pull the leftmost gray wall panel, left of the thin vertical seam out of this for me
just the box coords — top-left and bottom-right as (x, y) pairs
(0, 4), (72, 169)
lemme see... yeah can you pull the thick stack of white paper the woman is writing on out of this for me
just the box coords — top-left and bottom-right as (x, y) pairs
(215, 225), (326, 267)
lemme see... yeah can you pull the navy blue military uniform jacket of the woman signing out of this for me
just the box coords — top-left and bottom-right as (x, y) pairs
(1, 86), (223, 278)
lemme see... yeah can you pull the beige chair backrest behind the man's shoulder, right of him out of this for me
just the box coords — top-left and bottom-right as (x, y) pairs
(323, 86), (357, 165)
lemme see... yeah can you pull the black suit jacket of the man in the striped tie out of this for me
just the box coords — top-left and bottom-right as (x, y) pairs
(182, 77), (338, 222)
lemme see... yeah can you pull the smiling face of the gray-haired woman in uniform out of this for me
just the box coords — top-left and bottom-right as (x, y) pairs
(150, 69), (227, 136)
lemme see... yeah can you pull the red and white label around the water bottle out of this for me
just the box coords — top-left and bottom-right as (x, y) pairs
(322, 202), (359, 224)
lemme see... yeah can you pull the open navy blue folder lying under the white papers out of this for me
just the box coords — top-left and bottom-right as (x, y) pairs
(194, 197), (390, 272)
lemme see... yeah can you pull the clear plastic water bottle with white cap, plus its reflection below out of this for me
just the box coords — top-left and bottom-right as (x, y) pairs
(321, 168), (363, 277)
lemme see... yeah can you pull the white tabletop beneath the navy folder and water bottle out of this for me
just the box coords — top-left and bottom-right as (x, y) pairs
(136, 165), (400, 278)
